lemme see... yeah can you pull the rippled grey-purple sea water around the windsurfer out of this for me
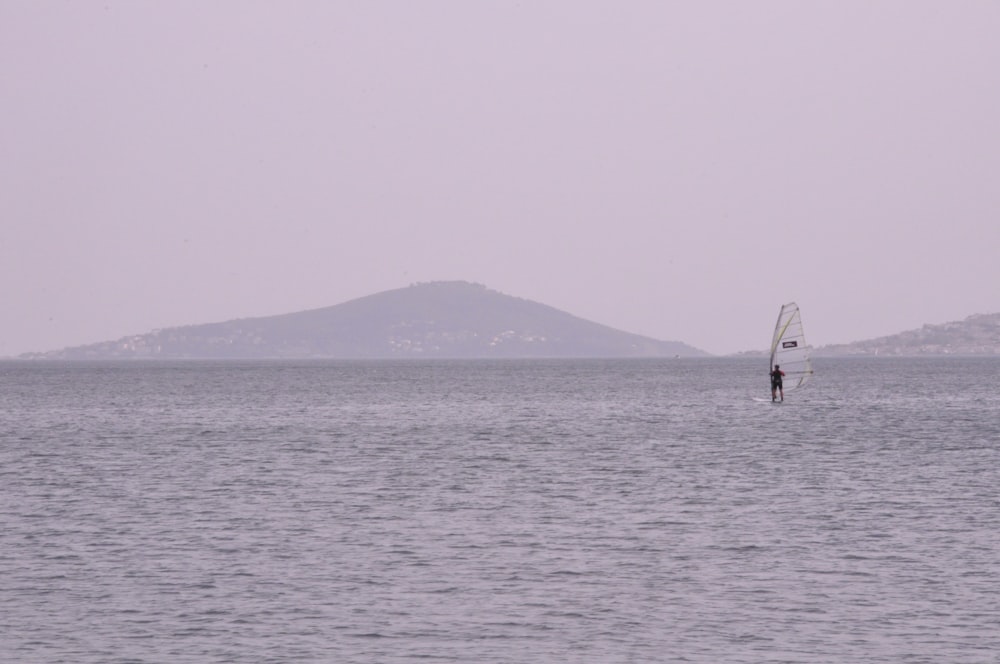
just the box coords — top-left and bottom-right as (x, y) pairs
(0, 359), (1000, 664)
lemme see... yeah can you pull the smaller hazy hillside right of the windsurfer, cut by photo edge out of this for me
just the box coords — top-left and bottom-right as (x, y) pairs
(814, 313), (1000, 356)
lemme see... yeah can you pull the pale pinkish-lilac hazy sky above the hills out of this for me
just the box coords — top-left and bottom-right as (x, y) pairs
(0, 0), (1000, 356)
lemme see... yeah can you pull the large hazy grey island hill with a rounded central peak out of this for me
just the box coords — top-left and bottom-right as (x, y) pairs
(22, 281), (707, 360)
